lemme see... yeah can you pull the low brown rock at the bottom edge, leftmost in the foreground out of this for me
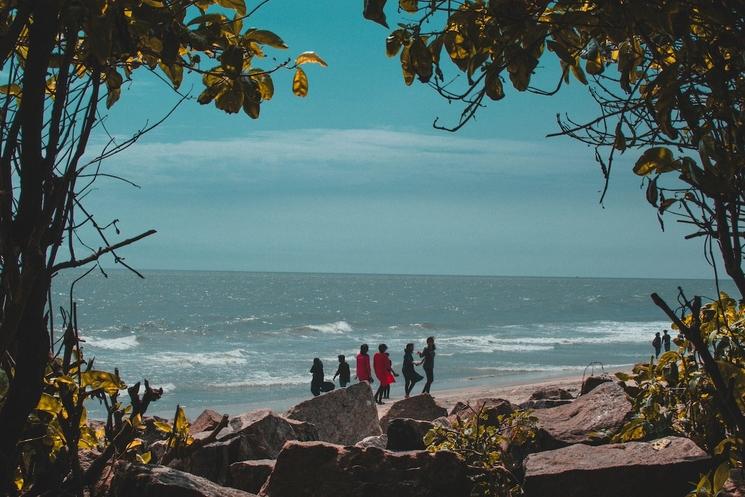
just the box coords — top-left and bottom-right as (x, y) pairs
(108, 461), (256, 497)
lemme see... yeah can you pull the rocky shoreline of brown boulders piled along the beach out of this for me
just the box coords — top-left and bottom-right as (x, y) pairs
(91, 377), (736, 497)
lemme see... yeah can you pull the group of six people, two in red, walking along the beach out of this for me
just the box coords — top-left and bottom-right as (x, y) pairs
(310, 337), (436, 404)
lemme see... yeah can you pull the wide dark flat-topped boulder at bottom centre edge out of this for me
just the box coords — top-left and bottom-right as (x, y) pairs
(260, 442), (471, 497)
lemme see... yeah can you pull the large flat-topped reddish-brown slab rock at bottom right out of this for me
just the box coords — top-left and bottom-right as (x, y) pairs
(524, 437), (710, 497)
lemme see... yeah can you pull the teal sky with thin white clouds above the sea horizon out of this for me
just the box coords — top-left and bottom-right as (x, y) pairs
(77, 0), (711, 278)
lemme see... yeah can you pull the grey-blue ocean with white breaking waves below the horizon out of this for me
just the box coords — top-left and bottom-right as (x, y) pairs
(53, 270), (733, 417)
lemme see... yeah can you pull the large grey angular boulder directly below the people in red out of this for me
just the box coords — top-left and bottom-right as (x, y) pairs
(287, 382), (382, 445)
